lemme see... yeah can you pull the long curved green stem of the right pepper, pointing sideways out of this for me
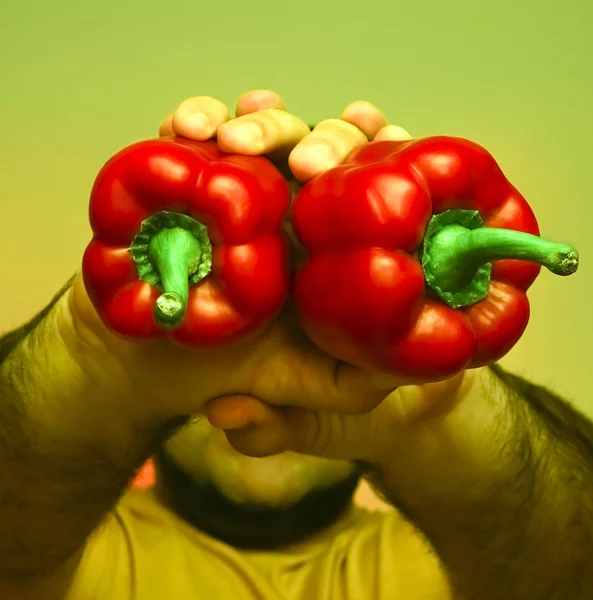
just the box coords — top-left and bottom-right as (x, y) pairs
(431, 224), (579, 292)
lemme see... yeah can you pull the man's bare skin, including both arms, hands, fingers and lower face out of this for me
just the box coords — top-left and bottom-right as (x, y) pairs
(0, 90), (593, 600)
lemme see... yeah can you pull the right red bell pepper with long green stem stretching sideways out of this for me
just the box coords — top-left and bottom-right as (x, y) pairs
(292, 137), (578, 383)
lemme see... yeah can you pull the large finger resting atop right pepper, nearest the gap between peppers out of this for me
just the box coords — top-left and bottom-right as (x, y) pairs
(288, 119), (368, 181)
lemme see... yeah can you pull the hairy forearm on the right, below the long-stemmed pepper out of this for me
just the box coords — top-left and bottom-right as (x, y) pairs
(366, 369), (593, 600)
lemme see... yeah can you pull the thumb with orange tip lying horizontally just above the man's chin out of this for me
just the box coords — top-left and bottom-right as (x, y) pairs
(206, 395), (382, 460)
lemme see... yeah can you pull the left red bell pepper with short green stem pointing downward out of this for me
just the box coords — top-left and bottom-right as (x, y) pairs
(83, 137), (290, 346)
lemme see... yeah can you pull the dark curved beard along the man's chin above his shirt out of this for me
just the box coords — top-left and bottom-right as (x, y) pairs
(154, 448), (362, 550)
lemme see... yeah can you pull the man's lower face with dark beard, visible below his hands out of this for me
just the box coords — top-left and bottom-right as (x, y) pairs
(155, 419), (359, 547)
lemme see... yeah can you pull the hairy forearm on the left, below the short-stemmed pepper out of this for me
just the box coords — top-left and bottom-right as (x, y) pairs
(0, 282), (184, 579)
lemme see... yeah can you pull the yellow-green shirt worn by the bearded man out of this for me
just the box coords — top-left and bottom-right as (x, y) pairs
(68, 490), (452, 600)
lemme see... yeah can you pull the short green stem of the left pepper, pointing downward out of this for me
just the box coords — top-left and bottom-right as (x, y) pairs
(148, 227), (202, 328)
